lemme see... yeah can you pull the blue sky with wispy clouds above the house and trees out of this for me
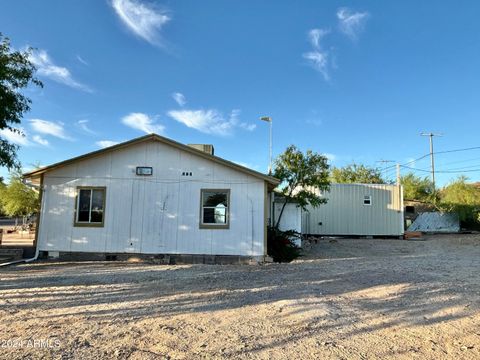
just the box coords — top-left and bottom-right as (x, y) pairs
(0, 0), (480, 184)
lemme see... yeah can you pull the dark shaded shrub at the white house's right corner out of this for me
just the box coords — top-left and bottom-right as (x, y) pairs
(267, 226), (301, 262)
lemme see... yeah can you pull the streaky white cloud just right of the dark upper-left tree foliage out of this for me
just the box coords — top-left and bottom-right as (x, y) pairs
(30, 50), (92, 92)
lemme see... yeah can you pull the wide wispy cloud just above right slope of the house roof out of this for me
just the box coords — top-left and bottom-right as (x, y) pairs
(168, 109), (256, 136)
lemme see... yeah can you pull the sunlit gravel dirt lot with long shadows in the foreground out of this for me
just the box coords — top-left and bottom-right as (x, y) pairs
(0, 235), (480, 359)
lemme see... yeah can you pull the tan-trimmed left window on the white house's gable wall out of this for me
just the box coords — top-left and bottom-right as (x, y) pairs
(75, 187), (106, 226)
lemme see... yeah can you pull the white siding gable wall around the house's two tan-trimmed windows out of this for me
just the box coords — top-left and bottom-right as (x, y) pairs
(39, 141), (266, 256)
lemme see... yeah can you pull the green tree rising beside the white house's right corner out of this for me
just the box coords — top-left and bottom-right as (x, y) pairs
(273, 145), (330, 229)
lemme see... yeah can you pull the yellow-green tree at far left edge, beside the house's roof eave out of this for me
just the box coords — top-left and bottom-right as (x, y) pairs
(0, 172), (40, 219)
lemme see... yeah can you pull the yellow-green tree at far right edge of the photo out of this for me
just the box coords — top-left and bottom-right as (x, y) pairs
(439, 176), (480, 226)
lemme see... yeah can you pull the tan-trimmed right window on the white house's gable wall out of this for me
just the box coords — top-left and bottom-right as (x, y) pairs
(200, 189), (230, 229)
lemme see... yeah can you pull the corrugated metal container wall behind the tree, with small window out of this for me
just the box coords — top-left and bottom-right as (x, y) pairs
(302, 184), (404, 236)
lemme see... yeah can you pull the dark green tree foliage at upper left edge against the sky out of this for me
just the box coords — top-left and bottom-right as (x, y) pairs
(0, 33), (43, 169)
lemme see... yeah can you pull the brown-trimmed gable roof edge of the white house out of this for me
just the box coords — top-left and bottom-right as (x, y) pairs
(23, 134), (280, 187)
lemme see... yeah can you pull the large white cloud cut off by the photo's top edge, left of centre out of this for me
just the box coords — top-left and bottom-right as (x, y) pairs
(112, 0), (171, 46)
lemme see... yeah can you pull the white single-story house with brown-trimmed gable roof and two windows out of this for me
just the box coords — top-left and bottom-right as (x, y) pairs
(24, 134), (279, 262)
